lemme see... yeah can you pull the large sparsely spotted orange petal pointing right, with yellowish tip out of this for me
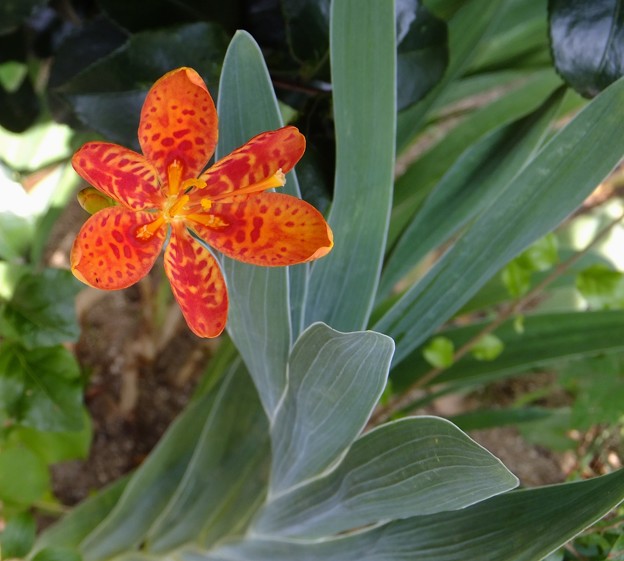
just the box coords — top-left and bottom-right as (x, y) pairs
(191, 193), (334, 266)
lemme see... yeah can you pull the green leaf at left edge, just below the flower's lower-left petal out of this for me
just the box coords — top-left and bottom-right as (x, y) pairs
(0, 269), (80, 349)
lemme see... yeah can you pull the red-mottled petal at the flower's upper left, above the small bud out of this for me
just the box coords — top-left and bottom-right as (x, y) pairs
(72, 142), (164, 210)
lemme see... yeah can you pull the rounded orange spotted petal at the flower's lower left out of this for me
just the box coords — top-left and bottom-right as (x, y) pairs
(70, 207), (166, 290)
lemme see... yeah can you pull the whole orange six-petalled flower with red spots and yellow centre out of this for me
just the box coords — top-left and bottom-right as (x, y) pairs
(71, 68), (333, 337)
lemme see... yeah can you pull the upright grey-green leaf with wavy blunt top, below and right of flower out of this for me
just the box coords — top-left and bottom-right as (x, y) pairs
(271, 324), (394, 494)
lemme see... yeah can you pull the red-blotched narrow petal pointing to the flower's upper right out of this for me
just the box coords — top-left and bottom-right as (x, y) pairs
(192, 126), (305, 199)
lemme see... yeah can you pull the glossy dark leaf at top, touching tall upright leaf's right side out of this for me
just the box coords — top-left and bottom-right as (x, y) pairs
(396, 0), (449, 111)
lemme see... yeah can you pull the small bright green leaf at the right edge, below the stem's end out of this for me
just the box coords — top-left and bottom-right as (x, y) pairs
(576, 264), (624, 310)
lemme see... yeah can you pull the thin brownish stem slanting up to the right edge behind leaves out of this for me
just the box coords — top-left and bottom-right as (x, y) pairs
(369, 212), (624, 426)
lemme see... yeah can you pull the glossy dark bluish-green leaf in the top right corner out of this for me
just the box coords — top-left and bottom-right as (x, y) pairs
(548, 0), (624, 97)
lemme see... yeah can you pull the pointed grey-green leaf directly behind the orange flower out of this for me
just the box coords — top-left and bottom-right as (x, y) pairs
(217, 32), (307, 417)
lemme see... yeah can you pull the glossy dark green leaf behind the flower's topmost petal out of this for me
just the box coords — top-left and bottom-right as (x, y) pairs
(54, 23), (227, 149)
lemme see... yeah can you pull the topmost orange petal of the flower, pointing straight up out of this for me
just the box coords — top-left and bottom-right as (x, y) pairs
(139, 68), (218, 181)
